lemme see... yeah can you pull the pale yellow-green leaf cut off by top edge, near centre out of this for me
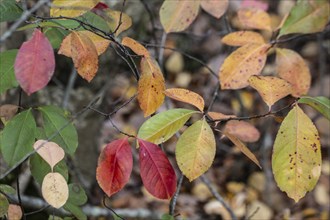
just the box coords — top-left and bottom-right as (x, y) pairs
(159, 0), (200, 33)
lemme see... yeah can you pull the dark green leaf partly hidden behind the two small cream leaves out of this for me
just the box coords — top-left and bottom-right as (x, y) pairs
(30, 154), (69, 185)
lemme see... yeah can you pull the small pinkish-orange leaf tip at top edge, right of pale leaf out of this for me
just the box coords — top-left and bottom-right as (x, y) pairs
(201, 0), (229, 18)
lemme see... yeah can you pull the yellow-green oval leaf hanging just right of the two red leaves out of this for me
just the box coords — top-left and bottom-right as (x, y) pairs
(175, 119), (216, 181)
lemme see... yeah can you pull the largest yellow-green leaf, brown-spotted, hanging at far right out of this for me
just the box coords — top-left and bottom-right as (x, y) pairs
(272, 105), (322, 202)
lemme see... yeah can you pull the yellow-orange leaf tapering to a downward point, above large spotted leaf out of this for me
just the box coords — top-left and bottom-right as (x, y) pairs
(249, 76), (292, 110)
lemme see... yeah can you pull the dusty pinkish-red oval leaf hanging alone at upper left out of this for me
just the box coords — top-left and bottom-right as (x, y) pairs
(14, 29), (55, 95)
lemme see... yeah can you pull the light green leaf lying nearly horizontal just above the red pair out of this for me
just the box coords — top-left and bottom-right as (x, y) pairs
(138, 108), (198, 144)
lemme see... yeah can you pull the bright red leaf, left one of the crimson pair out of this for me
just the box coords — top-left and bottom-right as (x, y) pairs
(96, 138), (133, 196)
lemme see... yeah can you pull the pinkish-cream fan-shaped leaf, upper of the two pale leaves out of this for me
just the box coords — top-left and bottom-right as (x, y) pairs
(33, 140), (65, 171)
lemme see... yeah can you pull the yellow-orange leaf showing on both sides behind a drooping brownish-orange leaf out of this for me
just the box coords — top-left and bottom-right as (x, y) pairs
(58, 31), (111, 57)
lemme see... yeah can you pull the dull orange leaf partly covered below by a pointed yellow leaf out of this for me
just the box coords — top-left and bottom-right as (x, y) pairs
(276, 48), (311, 97)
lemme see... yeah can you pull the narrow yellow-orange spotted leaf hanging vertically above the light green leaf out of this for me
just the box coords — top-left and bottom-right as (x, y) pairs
(137, 57), (165, 117)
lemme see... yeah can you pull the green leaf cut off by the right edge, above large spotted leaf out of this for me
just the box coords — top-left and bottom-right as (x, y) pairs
(298, 96), (330, 120)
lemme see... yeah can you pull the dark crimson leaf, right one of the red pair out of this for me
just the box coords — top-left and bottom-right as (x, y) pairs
(138, 139), (176, 199)
